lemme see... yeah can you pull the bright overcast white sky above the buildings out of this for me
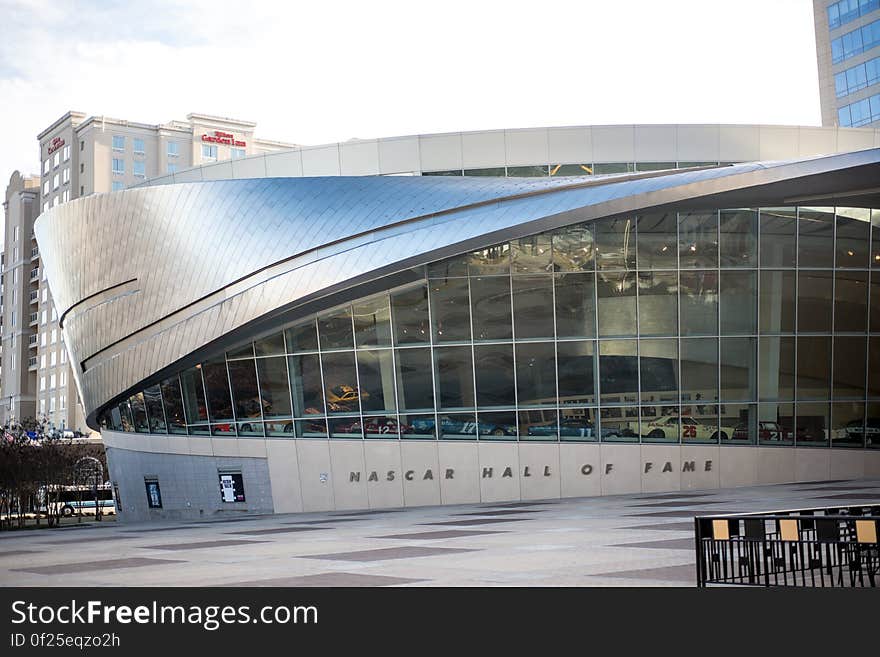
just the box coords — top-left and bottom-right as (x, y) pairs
(0, 0), (820, 181)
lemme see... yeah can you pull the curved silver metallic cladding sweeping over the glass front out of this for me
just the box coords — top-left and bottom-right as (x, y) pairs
(34, 149), (880, 425)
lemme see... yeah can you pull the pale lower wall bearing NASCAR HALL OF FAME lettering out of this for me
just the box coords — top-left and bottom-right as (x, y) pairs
(103, 431), (880, 520)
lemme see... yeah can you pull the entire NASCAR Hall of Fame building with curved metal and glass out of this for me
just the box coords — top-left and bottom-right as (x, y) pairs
(35, 126), (880, 520)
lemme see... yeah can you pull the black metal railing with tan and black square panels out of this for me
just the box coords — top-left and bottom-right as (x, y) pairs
(694, 502), (880, 587)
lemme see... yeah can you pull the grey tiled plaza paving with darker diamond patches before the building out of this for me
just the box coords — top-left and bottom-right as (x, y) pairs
(0, 478), (880, 587)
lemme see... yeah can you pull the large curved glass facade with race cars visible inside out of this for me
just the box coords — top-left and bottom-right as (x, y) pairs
(100, 207), (880, 448)
